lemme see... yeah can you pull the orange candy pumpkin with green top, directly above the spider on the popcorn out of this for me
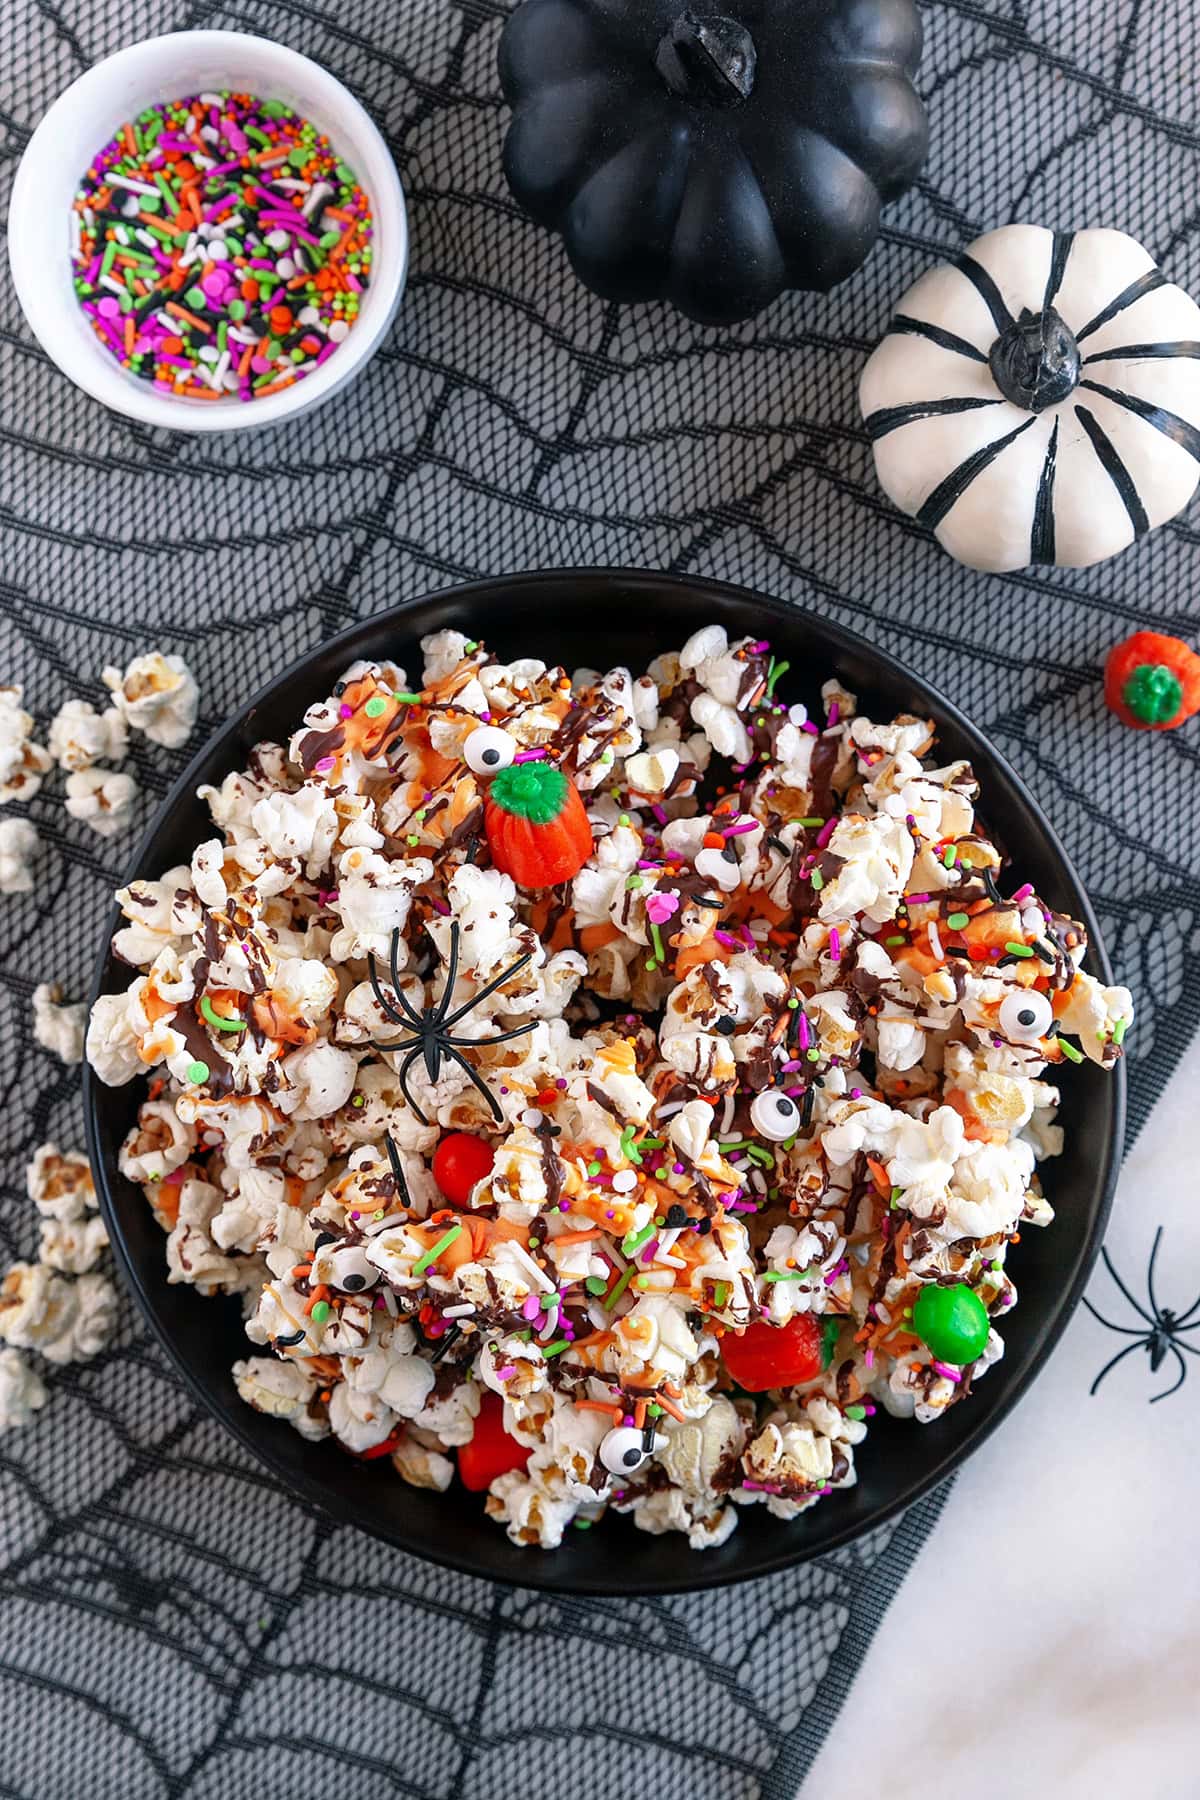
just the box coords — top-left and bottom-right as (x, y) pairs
(484, 761), (592, 887)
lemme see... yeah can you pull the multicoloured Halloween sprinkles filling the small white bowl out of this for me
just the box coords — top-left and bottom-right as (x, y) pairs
(72, 92), (372, 400)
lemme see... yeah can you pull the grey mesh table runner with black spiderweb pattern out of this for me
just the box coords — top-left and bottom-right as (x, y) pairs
(0, 0), (1200, 1800)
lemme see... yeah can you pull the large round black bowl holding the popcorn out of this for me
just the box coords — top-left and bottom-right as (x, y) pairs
(85, 571), (1124, 1595)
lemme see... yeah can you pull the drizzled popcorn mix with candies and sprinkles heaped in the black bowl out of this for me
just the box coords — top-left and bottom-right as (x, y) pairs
(89, 626), (1132, 1548)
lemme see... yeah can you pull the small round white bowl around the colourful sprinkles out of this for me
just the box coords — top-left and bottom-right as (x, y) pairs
(9, 31), (408, 432)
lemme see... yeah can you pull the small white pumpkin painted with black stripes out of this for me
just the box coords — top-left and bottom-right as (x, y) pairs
(858, 225), (1200, 571)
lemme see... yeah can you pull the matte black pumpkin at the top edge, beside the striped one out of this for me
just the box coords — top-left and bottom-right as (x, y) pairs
(500, 0), (927, 324)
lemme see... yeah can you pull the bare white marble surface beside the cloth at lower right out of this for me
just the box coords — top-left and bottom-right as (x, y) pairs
(802, 1040), (1200, 1800)
